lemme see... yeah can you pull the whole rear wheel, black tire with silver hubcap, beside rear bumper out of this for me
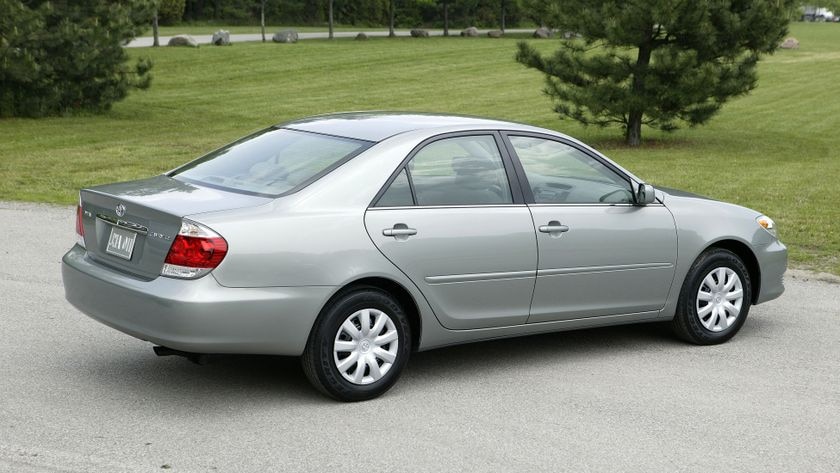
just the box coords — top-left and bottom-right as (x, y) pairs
(301, 287), (411, 401)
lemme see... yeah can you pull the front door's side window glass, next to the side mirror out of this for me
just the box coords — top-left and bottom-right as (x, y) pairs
(509, 136), (633, 204)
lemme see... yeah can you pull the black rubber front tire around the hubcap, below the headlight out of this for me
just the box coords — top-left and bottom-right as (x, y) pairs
(672, 248), (752, 345)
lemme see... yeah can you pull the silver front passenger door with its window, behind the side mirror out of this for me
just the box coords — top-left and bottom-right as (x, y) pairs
(506, 134), (677, 323)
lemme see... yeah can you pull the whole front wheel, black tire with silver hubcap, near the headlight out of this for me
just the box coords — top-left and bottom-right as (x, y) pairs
(672, 248), (752, 345)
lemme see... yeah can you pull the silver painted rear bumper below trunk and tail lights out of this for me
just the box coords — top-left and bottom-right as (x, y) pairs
(61, 245), (334, 356)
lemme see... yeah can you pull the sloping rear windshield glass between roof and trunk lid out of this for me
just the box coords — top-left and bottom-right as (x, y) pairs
(170, 128), (371, 196)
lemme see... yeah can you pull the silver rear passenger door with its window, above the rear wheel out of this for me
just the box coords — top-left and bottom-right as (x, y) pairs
(365, 132), (537, 329)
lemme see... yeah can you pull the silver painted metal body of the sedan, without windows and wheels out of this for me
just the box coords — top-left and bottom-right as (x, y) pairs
(62, 113), (787, 355)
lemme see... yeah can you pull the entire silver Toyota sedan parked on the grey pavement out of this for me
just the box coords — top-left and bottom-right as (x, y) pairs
(62, 113), (787, 401)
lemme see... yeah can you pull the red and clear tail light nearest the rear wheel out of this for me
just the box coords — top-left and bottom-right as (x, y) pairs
(160, 220), (227, 279)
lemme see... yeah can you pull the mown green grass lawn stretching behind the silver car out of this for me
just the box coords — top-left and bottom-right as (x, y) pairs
(0, 23), (840, 274)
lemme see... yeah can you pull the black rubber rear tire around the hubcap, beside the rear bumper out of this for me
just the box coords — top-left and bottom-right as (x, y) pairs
(301, 286), (411, 402)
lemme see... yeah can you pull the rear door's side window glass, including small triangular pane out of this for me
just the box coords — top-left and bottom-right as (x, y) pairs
(386, 135), (513, 206)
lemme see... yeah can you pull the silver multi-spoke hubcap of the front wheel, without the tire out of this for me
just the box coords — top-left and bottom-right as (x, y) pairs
(696, 267), (744, 332)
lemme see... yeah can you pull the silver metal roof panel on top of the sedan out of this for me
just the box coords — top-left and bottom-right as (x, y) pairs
(279, 112), (536, 142)
